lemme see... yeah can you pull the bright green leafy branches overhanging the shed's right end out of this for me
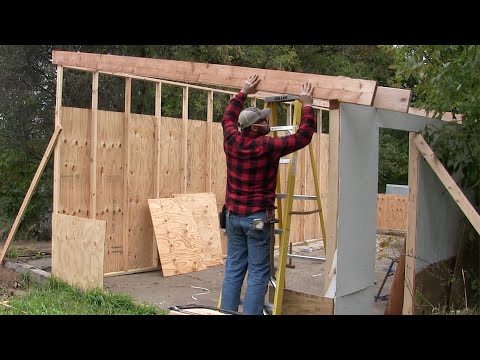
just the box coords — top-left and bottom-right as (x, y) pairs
(387, 45), (480, 205)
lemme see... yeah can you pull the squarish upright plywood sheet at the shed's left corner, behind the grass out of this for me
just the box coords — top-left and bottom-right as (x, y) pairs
(52, 214), (106, 290)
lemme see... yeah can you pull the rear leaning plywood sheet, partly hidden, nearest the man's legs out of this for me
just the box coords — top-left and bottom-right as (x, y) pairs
(173, 193), (223, 266)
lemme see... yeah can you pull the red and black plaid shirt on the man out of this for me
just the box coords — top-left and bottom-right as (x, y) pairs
(222, 92), (316, 216)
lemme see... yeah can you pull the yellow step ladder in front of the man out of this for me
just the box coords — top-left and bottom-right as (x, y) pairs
(265, 95), (327, 315)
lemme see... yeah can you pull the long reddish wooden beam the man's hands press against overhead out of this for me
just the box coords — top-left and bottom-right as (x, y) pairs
(52, 50), (377, 106)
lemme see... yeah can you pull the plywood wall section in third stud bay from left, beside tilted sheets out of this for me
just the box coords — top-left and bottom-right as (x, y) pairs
(127, 114), (156, 270)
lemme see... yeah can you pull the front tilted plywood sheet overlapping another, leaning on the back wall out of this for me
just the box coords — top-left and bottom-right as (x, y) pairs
(148, 198), (207, 276)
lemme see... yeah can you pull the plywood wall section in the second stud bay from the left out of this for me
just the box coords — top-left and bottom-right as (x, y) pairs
(96, 111), (124, 273)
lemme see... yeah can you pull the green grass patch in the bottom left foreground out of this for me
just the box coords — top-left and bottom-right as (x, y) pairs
(0, 278), (166, 315)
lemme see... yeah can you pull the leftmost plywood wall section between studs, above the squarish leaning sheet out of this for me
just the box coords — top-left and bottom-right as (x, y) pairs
(58, 107), (92, 218)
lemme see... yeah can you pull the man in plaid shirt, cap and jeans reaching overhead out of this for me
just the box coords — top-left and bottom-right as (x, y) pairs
(221, 75), (316, 315)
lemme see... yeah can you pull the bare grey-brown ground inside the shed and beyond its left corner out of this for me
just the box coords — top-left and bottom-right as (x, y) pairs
(0, 234), (404, 315)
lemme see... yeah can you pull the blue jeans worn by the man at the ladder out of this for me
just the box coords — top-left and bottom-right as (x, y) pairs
(221, 211), (270, 315)
